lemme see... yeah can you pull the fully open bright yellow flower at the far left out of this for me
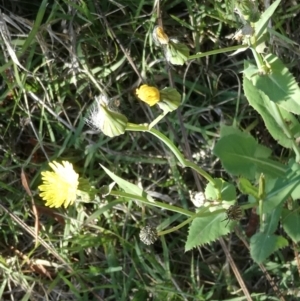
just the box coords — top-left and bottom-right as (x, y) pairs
(39, 161), (79, 208)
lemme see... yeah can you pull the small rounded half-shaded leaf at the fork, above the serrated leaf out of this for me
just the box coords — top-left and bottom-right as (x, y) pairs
(205, 179), (236, 201)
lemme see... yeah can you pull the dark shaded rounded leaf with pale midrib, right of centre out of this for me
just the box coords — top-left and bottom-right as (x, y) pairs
(213, 133), (287, 179)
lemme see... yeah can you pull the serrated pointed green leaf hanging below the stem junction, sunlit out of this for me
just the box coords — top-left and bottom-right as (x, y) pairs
(185, 213), (232, 251)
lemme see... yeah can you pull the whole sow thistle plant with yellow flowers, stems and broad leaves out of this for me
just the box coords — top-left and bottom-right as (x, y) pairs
(40, 0), (300, 263)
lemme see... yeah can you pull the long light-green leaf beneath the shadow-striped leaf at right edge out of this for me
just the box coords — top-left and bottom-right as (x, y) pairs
(243, 76), (300, 148)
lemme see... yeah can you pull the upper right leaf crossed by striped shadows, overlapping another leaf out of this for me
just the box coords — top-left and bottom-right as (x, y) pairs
(244, 54), (300, 114)
